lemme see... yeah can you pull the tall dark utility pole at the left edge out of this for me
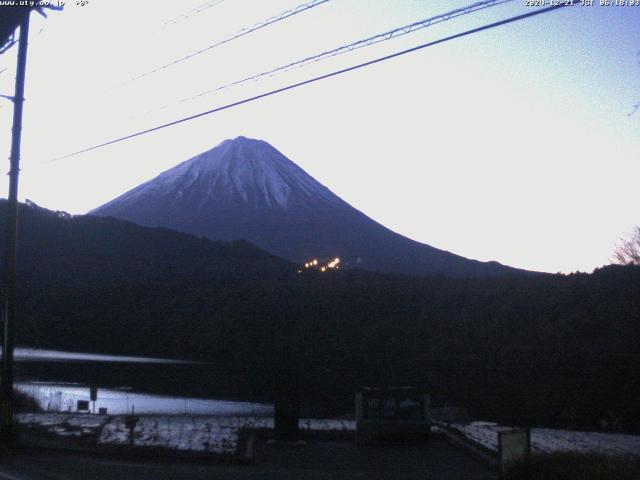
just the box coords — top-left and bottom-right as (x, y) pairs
(0, 10), (31, 446)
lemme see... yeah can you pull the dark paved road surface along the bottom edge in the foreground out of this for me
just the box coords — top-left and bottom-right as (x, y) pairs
(0, 440), (497, 480)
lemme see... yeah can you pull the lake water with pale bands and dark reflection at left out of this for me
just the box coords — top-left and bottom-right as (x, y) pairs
(15, 348), (273, 416)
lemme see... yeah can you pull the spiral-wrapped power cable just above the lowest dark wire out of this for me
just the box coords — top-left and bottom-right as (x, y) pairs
(178, 0), (513, 107)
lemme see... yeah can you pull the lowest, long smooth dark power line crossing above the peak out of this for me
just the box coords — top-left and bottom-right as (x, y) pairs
(50, 3), (571, 162)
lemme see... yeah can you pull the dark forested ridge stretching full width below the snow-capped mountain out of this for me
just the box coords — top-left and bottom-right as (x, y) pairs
(0, 204), (640, 432)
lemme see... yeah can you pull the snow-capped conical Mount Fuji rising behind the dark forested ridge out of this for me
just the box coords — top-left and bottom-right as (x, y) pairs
(89, 137), (523, 277)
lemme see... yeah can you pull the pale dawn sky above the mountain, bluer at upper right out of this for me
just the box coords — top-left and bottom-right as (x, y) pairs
(0, 0), (640, 273)
